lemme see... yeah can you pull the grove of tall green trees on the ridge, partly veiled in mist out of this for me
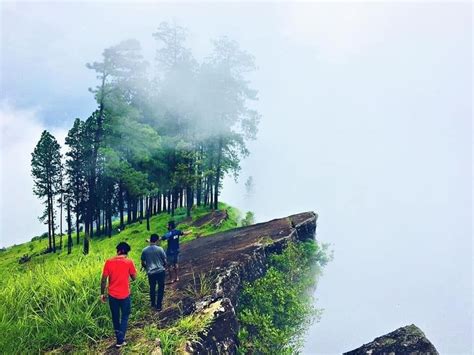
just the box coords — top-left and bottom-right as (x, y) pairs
(32, 22), (260, 253)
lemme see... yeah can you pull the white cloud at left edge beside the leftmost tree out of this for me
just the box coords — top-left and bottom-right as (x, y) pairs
(0, 101), (66, 247)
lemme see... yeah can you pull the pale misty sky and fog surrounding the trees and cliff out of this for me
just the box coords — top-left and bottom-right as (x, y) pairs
(0, 3), (473, 354)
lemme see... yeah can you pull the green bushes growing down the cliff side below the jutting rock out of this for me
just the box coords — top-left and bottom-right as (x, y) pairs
(237, 241), (331, 354)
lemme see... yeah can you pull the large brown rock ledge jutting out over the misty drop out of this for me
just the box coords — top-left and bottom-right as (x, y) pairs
(156, 212), (317, 354)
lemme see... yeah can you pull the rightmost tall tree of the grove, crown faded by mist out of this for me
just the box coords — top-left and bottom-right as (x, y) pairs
(200, 37), (260, 209)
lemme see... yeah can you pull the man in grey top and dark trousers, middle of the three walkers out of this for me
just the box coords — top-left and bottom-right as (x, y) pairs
(141, 234), (166, 311)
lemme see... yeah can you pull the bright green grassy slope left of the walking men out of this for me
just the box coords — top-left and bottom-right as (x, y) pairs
(0, 204), (239, 353)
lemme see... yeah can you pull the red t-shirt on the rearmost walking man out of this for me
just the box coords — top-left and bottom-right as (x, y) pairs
(102, 256), (137, 299)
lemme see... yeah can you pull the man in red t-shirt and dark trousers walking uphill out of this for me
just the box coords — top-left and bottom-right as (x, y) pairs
(100, 242), (137, 348)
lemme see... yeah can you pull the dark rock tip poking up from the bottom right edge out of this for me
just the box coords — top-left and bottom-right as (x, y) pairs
(344, 324), (438, 355)
